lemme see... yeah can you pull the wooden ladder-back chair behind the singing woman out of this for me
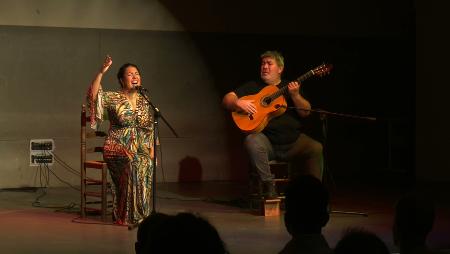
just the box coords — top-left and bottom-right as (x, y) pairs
(81, 105), (108, 222)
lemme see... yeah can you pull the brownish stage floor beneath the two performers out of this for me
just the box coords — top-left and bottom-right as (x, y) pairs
(0, 181), (450, 254)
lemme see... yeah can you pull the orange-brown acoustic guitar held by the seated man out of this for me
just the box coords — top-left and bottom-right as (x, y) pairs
(231, 64), (333, 133)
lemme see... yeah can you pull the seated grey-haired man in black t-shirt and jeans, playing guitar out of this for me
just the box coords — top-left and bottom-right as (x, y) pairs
(222, 51), (323, 198)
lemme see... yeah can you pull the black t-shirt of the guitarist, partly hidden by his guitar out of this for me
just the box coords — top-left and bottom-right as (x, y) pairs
(234, 80), (302, 145)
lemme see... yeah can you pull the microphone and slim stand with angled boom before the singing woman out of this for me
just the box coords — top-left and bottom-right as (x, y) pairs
(136, 86), (180, 214)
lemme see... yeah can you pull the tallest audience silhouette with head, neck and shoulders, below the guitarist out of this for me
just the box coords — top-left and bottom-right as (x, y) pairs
(280, 175), (331, 254)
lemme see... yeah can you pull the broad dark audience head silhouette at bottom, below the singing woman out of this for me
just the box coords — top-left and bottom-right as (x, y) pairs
(137, 213), (228, 254)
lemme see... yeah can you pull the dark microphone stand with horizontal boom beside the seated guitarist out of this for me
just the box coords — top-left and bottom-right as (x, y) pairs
(288, 107), (377, 217)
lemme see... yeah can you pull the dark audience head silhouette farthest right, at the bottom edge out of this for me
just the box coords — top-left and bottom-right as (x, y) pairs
(393, 193), (435, 253)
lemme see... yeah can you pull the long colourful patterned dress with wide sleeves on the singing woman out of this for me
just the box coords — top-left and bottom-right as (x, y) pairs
(88, 88), (154, 225)
